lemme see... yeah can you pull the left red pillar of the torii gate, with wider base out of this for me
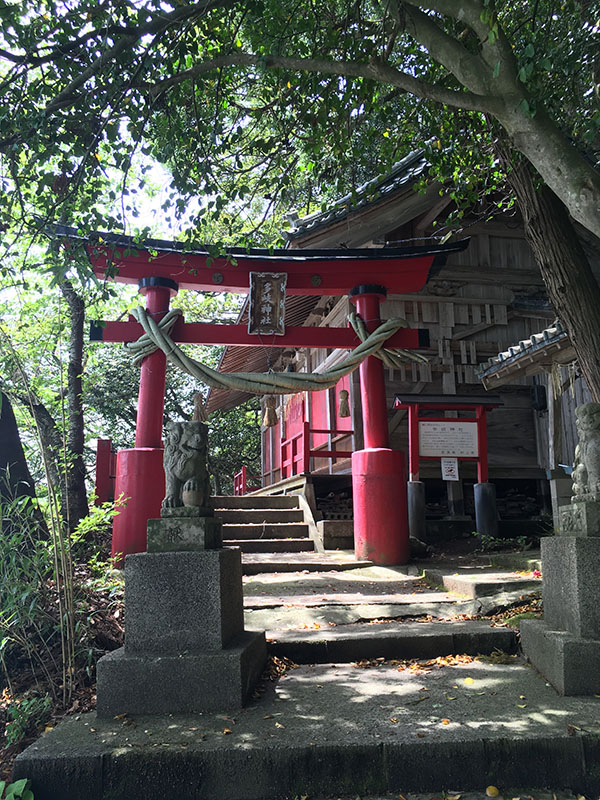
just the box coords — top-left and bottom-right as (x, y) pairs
(112, 278), (178, 560)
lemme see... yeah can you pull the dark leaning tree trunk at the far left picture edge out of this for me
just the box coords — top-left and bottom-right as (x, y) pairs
(0, 392), (48, 536)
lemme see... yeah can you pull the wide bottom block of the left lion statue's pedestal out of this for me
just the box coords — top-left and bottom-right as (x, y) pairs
(97, 632), (267, 717)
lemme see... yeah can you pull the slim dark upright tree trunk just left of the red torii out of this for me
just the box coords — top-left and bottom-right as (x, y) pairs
(60, 281), (89, 531)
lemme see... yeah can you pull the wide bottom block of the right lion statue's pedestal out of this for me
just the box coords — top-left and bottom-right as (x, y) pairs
(521, 619), (600, 695)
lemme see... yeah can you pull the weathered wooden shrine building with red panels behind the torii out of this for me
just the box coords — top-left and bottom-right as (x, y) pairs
(208, 153), (572, 531)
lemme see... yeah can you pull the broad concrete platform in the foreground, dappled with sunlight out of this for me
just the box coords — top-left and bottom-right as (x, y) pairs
(15, 659), (600, 800)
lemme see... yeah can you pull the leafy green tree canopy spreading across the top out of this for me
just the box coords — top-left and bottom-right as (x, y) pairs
(0, 0), (600, 247)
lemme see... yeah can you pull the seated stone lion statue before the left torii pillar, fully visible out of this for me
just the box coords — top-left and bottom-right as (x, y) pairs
(162, 421), (210, 509)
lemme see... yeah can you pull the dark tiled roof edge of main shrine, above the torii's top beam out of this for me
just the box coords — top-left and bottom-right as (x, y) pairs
(283, 150), (429, 240)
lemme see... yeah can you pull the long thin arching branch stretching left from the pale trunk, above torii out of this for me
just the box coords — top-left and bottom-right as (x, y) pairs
(140, 53), (497, 114)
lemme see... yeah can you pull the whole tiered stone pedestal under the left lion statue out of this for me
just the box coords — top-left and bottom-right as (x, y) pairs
(97, 515), (267, 717)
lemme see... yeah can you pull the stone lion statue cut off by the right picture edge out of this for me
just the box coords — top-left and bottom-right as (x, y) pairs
(572, 403), (600, 501)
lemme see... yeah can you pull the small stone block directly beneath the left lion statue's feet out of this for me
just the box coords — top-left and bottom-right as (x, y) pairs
(148, 515), (223, 553)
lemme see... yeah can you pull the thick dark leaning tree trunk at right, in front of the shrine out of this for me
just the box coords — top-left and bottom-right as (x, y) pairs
(508, 163), (600, 402)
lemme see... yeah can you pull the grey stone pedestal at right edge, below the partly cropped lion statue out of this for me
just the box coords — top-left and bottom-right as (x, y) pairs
(521, 536), (600, 695)
